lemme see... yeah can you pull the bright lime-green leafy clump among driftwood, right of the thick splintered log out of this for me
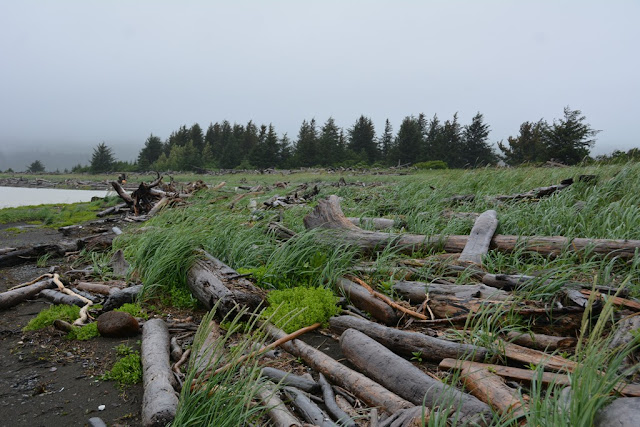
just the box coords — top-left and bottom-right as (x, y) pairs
(263, 287), (339, 333)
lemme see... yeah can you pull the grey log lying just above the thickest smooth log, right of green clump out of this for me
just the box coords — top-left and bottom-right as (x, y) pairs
(329, 316), (487, 361)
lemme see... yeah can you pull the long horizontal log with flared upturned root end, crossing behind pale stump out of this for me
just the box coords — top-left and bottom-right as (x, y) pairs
(304, 196), (640, 258)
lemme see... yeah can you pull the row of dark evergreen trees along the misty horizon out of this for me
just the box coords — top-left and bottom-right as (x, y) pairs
(66, 107), (599, 172)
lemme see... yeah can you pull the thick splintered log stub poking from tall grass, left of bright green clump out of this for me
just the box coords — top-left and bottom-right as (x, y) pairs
(187, 251), (264, 316)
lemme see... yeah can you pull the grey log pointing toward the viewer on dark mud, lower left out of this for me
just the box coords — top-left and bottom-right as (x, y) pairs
(141, 319), (178, 427)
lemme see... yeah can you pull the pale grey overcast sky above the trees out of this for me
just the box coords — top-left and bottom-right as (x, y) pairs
(0, 0), (640, 169)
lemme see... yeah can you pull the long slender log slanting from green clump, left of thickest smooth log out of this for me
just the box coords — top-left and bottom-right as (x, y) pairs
(267, 325), (412, 414)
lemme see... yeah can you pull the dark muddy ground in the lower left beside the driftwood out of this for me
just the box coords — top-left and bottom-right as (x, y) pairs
(0, 224), (142, 427)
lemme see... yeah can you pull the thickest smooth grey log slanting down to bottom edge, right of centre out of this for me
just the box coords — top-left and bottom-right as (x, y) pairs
(340, 329), (492, 425)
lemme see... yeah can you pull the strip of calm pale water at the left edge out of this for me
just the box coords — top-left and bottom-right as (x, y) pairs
(0, 187), (107, 209)
